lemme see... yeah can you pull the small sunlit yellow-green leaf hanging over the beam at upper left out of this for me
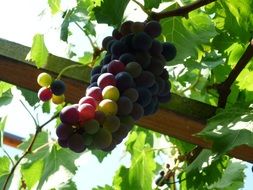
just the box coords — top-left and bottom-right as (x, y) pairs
(26, 34), (49, 68)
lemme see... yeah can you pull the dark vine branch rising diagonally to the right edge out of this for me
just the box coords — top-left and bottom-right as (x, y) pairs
(215, 39), (253, 108)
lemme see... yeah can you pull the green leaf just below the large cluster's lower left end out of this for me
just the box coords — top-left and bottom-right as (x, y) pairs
(38, 145), (80, 189)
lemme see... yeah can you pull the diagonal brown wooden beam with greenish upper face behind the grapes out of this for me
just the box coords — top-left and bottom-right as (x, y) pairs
(0, 37), (253, 163)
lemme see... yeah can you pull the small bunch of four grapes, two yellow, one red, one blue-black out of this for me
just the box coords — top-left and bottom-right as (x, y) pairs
(37, 73), (66, 104)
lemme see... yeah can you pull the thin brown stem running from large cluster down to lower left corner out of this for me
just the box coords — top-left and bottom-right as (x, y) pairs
(3, 112), (60, 190)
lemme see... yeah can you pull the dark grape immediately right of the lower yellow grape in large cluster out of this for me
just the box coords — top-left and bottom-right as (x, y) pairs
(117, 96), (133, 115)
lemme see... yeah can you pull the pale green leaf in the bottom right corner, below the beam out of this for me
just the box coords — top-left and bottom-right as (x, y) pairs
(208, 161), (246, 190)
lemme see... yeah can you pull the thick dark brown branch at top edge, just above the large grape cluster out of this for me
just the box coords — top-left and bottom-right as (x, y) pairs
(149, 0), (217, 21)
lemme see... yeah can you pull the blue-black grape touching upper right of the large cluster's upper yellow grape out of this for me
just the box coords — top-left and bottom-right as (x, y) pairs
(115, 72), (134, 91)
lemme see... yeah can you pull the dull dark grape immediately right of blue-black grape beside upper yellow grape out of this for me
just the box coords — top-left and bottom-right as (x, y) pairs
(135, 71), (155, 88)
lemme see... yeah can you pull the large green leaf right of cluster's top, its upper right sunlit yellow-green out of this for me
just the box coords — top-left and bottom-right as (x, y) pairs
(161, 11), (217, 65)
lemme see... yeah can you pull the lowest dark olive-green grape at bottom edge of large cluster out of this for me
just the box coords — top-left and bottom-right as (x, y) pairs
(93, 128), (112, 149)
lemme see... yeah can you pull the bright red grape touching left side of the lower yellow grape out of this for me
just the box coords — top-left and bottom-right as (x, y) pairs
(78, 103), (96, 122)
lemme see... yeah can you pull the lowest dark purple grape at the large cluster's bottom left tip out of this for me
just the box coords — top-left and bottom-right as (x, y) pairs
(68, 133), (86, 153)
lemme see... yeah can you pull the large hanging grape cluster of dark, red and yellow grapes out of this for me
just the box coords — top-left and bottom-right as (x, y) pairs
(56, 21), (176, 152)
